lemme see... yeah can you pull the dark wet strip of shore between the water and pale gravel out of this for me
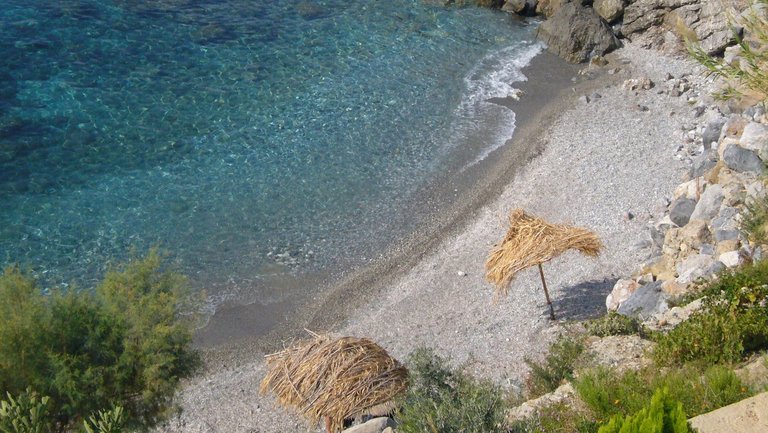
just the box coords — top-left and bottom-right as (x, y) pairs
(196, 49), (588, 358)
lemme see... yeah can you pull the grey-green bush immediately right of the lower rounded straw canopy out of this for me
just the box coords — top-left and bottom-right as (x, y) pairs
(395, 349), (504, 433)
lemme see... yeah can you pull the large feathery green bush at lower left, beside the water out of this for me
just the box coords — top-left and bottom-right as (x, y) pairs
(0, 250), (199, 431)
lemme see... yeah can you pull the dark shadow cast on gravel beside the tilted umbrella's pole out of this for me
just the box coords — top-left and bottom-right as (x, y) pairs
(553, 278), (618, 320)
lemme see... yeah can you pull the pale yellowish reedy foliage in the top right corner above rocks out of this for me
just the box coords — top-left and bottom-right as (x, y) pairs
(688, 0), (768, 101)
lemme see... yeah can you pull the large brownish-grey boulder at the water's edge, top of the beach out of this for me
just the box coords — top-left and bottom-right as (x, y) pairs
(537, 3), (621, 63)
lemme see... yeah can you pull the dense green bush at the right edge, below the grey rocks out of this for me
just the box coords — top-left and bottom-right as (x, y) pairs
(653, 261), (768, 365)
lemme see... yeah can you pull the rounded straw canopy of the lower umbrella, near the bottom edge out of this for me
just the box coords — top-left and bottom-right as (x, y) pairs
(260, 334), (408, 433)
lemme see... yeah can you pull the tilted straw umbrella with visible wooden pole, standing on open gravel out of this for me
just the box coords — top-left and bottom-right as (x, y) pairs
(485, 209), (603, 320)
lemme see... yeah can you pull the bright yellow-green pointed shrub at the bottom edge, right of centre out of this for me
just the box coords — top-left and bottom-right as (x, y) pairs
(598, 388), (691, 433)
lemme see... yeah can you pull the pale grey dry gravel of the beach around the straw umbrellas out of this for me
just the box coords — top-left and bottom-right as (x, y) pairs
(159, 45), (716, 433)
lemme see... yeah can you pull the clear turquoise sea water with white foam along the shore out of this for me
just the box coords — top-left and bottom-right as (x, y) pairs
(0, 0), (540, 305)
